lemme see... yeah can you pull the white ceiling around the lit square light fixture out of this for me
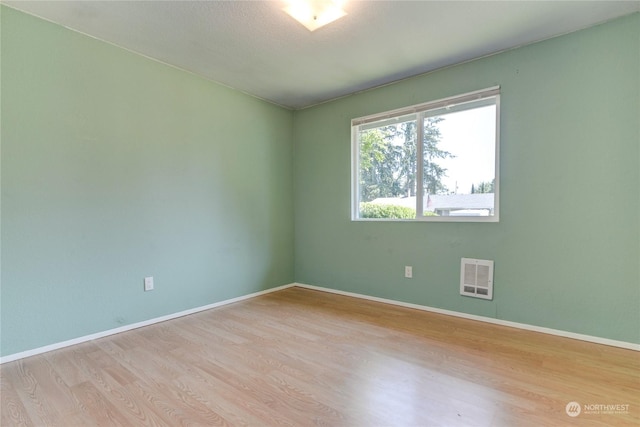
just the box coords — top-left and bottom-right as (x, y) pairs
(2, 0), (640, 108)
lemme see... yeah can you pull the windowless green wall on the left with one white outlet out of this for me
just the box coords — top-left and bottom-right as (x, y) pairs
(0, 6), (294, 355)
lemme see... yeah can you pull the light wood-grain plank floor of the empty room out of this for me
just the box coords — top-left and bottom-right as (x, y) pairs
(0, 288), (640, 427)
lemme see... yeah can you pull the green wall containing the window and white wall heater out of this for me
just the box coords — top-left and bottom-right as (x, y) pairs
(294, 14), (640, 343)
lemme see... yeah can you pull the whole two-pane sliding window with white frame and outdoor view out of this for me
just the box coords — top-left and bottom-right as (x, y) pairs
(351, 87), (500, 222)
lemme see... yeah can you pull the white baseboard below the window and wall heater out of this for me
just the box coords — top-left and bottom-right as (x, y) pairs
(293, 283), (640, 351)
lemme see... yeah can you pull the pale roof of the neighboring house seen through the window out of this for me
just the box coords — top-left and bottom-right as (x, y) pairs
(371, 193), (494, 212)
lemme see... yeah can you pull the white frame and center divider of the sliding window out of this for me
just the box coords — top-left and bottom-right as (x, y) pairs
(351, 86), (500, 222)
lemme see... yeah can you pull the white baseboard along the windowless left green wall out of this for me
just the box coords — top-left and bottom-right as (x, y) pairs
(0, 283), (295, 365)
